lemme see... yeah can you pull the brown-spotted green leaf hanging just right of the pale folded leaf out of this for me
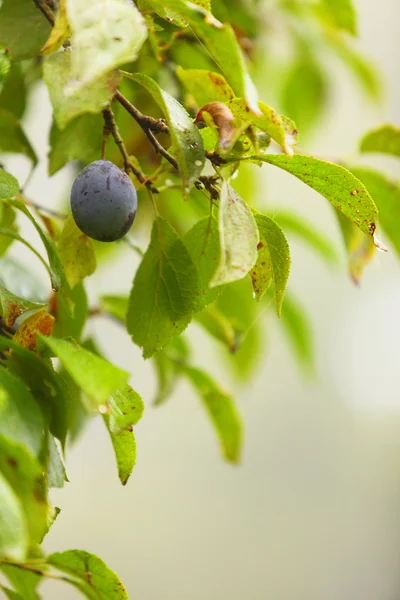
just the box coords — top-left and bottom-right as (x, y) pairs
(250, 213), (290, 316)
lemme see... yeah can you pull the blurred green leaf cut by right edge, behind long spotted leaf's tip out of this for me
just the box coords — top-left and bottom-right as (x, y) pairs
(351, 167), (400, 256)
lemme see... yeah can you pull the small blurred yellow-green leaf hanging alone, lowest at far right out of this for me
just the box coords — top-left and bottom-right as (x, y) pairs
(281, 294), (314, 371)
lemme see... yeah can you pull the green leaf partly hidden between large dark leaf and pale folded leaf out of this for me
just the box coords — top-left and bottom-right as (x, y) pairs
(183, 217), (222, 311)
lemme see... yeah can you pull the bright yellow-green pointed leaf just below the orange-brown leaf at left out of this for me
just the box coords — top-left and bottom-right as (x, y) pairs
(38, 335), (128, 409)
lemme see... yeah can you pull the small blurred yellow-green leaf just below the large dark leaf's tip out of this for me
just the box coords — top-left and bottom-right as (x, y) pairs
(153, 336), (189, 405)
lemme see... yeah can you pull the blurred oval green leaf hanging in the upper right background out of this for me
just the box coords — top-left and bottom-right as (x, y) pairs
(281, 48), (327, 134)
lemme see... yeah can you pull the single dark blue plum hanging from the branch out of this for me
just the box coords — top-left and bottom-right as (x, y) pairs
(71, 160), (137, 242)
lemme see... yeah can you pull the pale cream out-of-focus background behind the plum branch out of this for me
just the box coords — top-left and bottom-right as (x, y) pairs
(7, 0), (400, 600)
